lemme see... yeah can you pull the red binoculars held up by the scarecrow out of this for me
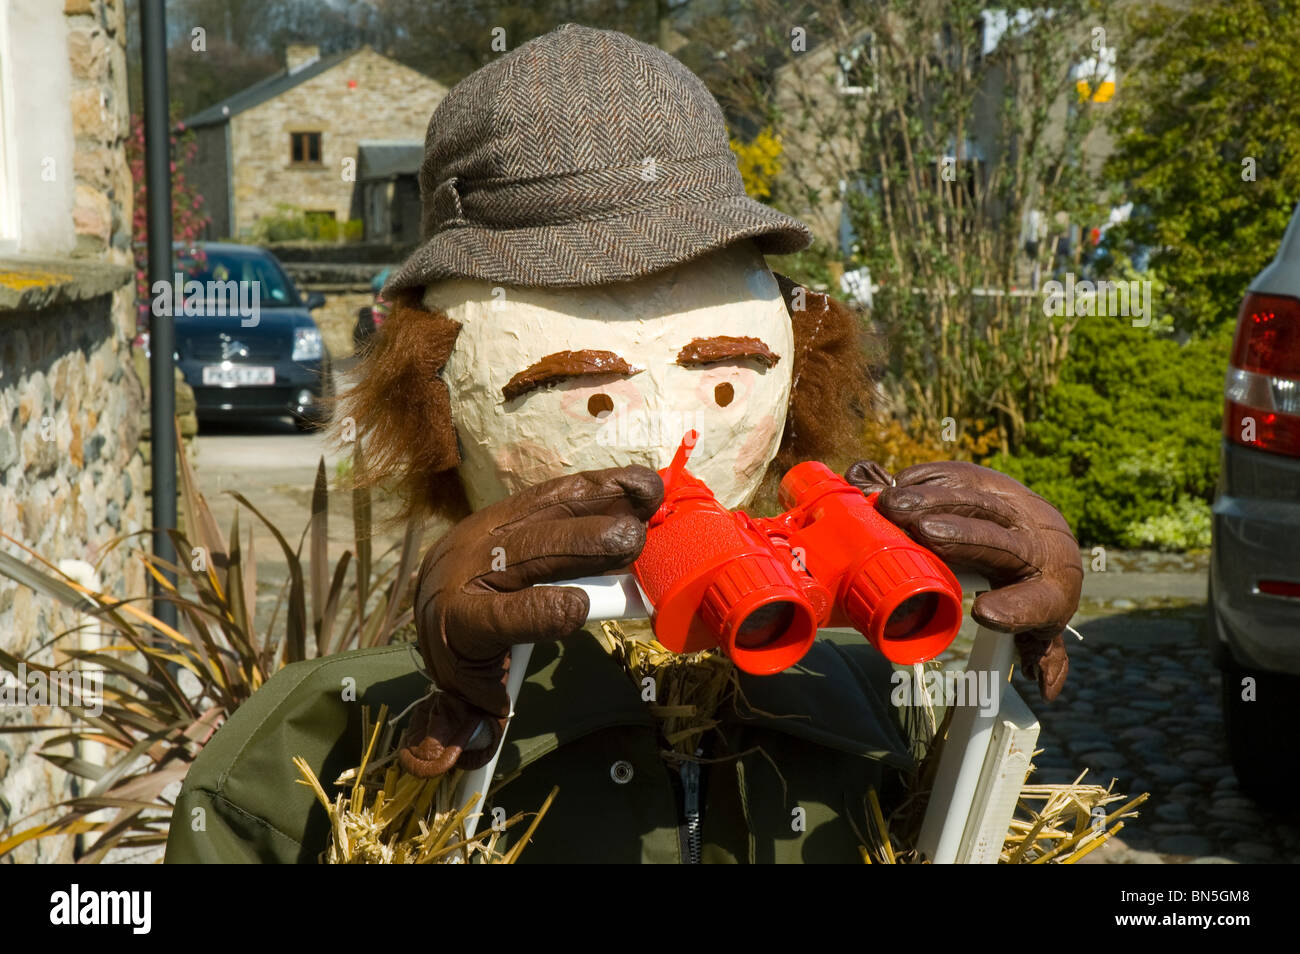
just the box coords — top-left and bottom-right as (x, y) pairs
(632, 432), (962, 676)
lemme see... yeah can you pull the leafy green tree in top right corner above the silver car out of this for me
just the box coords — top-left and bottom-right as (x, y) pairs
(1106, 0), (1300, 334)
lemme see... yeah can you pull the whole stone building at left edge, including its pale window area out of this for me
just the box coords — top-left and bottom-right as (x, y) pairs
(0, 0), (147, 860)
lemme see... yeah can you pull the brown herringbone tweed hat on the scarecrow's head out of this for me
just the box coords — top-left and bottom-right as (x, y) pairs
(384, 23), (811, 298)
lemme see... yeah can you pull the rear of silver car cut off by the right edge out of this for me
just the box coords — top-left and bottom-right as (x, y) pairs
(1206, 207), (1300, 801)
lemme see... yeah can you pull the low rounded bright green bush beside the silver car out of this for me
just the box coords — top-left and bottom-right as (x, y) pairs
(985, 317), (1232, 550)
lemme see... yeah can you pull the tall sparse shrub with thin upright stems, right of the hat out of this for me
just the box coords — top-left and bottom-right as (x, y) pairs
(720, 0), (1100, 450)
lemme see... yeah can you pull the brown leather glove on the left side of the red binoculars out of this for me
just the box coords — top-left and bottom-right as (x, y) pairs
(398, 467), (663, 779)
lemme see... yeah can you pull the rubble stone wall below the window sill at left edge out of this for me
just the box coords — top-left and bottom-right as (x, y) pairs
(0, 273), (147, 860)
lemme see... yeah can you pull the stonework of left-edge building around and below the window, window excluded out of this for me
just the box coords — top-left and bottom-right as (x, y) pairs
(0, 0), (148, 862)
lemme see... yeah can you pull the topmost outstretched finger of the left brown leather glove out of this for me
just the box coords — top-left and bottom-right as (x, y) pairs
(476, 465), (663, 533)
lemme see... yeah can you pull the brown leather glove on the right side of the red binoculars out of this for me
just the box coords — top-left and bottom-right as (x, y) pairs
(844, 460), (1083, 702)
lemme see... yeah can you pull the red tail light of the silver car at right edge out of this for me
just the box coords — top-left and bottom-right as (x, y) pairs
(1223, 294), (1300, 458)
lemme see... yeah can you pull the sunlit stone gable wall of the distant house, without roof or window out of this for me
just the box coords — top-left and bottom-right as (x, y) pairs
(230, 47), (446, 235)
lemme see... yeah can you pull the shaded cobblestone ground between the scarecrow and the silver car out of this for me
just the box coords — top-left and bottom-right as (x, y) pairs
(1015, 554), (1300, 863)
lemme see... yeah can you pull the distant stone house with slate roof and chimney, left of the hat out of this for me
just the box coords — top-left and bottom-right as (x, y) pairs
(183, 45), (447, 239)
